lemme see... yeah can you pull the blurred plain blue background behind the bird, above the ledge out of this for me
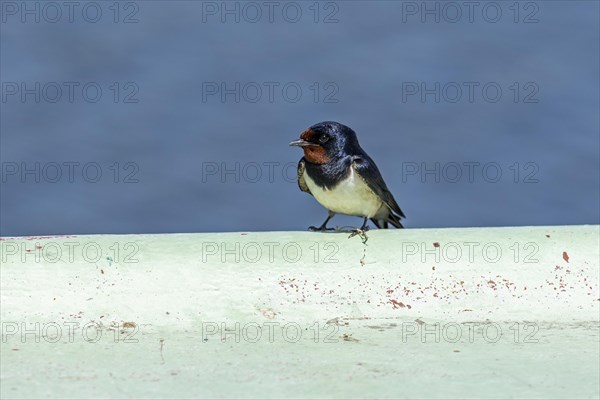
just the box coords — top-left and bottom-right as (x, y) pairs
(0, 1), (600, 236)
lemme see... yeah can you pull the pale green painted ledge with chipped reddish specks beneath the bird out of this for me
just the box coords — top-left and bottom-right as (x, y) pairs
(0, 226), (600, 399)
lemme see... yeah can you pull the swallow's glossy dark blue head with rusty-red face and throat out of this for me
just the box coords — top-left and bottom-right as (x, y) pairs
(290, 121), (360, 164)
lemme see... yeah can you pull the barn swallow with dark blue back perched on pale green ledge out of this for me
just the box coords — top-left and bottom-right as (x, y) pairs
(290, 121), (406, 231)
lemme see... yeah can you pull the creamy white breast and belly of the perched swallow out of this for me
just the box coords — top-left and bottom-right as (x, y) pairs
(304, 167), (382, 218)
